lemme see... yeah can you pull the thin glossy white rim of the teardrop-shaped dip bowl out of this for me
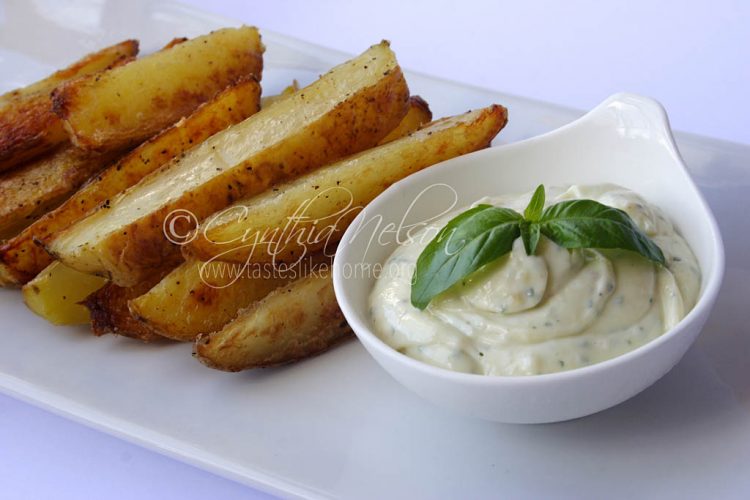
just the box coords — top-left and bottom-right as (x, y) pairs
(333, 93), (725, 386)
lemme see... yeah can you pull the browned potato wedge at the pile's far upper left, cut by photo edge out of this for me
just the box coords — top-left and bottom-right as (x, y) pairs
(0, 40), (138, 172)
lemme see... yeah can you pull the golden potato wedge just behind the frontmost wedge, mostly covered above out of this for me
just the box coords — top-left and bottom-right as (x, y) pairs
(129, 260), (295, 341)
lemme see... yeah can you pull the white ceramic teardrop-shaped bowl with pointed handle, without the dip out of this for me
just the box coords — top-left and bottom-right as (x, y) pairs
(333, 94), (724, 423)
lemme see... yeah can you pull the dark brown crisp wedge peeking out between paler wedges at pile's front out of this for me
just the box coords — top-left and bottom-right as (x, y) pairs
(82, 274), (169, 342)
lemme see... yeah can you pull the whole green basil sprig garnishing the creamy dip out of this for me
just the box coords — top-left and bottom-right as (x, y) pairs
(411, 185), (665, 309)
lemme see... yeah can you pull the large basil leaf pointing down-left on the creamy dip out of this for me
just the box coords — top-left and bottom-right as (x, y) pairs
(411, 205), (523, 309)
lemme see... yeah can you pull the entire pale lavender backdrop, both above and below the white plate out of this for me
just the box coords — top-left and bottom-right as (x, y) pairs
(0, 0), (750, 499)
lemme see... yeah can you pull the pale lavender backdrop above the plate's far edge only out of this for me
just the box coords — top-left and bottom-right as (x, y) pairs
(188, 0), (750, 143)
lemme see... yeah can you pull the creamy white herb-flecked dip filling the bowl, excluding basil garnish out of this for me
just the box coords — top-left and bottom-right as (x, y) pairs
(370, 184), (701, 375)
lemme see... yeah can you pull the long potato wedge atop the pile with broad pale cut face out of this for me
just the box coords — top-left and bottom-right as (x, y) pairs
(47, 42), (409, 286)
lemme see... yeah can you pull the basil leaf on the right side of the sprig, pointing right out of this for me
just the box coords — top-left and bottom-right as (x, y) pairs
(539, 200), (665, 265)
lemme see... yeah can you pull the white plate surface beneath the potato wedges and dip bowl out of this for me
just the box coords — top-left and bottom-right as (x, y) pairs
(0, 0), (750, 498)
